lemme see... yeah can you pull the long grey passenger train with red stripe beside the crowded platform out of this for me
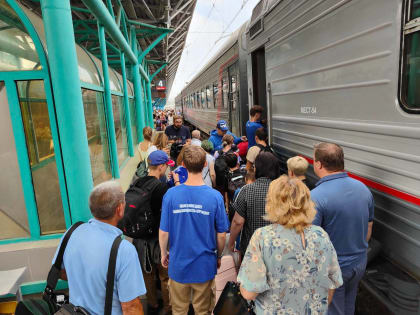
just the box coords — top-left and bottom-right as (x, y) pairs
(175, 0), (420, 314)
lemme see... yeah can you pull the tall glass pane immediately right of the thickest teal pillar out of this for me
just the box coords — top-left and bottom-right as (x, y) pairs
(82, 89), (112, 185)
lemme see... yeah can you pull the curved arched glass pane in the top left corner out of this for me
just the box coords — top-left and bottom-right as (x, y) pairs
(0, 0), (41, 71)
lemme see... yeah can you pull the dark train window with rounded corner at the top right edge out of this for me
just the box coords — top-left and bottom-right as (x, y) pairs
(400, 0), (420, 114)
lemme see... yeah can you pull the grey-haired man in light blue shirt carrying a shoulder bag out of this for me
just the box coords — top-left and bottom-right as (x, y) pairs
(53, 181), (146, 315)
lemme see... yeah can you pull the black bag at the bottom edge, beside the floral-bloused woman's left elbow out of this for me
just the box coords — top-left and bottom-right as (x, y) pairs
(213, 281), (255, 315)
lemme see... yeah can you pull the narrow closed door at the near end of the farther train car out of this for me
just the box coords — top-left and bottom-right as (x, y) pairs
(228, 62), (241, 136)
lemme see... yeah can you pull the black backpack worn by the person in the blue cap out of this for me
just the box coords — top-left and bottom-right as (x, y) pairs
(118, 178), (160, 239)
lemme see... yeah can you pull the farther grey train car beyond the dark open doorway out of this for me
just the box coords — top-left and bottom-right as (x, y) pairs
(175, 25), (248, 135)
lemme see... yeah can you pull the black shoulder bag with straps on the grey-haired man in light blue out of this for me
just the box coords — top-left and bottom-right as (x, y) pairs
(15, 222), (122, 315)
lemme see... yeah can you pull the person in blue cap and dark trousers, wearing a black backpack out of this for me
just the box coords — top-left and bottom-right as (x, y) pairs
(133, 150), (177, 315)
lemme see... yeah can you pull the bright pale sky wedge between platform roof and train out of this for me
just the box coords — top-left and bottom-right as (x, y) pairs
(167, 0), (259, 105)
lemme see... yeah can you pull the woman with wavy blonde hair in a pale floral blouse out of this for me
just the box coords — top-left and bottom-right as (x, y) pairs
(238, 175), (343, 314)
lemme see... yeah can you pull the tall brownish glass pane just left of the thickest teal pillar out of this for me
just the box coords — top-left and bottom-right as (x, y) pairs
(17, 80), (66, 234)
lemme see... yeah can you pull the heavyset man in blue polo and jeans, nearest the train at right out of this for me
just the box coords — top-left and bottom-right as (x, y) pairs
(311, 143), (374, 315)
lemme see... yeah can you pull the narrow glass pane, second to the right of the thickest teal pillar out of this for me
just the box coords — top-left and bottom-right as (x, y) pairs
(112, 95), (128, 165)
